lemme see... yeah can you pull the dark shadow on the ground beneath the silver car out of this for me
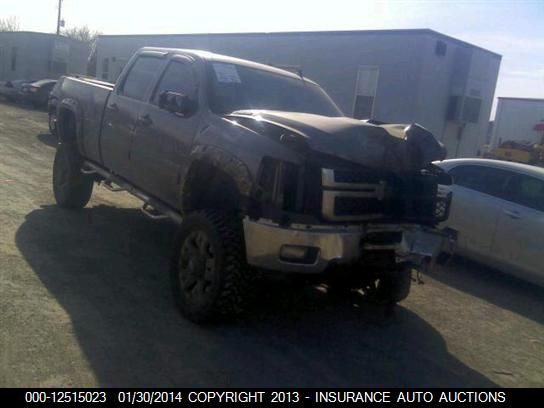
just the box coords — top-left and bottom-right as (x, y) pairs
(430, 256), (544, 324)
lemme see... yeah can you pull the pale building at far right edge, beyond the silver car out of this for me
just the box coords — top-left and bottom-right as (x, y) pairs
(491, 97), (544, 148)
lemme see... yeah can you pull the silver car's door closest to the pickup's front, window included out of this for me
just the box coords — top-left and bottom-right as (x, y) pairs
(448, 165), (511, 259)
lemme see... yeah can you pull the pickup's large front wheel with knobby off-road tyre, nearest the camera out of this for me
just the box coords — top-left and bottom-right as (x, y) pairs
(170, 211), (254, 323)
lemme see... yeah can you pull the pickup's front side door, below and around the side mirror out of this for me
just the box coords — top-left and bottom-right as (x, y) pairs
(131, 55), (202, 207)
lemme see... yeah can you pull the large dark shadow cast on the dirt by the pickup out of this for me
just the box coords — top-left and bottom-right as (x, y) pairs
(16, 206), (495, 387)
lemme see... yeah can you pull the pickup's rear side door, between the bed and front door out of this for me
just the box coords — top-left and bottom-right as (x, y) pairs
(100, 53), (164, 182)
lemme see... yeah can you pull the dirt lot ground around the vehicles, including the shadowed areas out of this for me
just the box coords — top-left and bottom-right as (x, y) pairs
(0, 102), (544, 387)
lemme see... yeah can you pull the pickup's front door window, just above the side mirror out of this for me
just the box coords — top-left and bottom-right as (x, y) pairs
(152, 61), (198, 105)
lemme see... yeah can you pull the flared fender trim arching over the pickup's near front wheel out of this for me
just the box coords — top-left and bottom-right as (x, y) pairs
(181, 145), (254, 208)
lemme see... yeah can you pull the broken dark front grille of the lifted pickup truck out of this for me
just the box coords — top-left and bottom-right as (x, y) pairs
(322, 169), (451, 223)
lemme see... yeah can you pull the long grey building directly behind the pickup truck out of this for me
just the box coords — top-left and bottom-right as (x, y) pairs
(96, 29), (501, 157)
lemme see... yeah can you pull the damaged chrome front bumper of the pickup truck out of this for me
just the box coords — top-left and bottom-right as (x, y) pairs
(244, 217), (455, 273)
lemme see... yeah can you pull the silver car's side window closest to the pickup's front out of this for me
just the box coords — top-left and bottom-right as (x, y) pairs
(449, 166), (514, 198)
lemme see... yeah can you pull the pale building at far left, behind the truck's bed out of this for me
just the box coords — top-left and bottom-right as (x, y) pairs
(0, 31), (90, 81)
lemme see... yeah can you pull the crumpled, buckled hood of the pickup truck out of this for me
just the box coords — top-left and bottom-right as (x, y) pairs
(227, 110), (445, 171)
